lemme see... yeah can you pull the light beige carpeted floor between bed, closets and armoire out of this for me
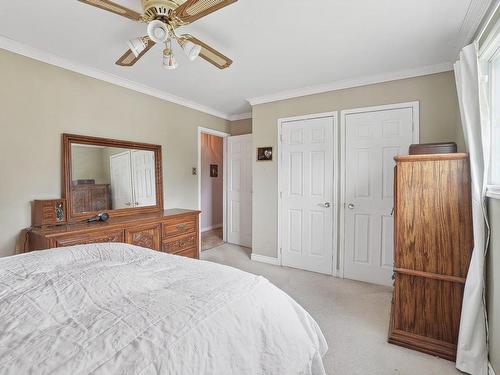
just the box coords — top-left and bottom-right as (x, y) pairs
(202, 244), (461, 375)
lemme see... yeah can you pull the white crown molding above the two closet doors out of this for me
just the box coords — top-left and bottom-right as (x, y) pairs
(247, 63), (453, 106)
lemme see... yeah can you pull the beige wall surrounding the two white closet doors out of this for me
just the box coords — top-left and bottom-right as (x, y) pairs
(252, 72), (464, 257)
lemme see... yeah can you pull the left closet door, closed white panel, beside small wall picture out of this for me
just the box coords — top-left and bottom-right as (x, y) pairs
(280, 117), (335, 275)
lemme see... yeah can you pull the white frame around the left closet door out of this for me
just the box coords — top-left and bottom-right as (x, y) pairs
(276, 111), (339, 276)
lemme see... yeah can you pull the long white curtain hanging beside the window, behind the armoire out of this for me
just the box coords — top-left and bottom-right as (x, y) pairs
(455, 43), (490, 375)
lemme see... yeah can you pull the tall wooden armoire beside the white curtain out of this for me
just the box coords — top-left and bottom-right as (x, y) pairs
(389, 153), (473, 360)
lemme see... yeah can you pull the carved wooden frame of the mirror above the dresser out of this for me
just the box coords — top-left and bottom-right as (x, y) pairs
(61, 134), (164, 223)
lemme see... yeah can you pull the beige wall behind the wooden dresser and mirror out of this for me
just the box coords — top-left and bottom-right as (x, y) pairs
(0, 50), (229, 256)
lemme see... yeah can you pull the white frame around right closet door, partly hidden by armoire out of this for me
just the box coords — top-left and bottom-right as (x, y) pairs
(338, 101), (420, 278)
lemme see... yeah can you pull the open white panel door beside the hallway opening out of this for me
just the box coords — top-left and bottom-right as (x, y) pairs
(227, 135), (253, 247)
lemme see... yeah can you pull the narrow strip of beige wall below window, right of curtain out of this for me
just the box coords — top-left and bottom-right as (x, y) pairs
(486, 199), (500, 374)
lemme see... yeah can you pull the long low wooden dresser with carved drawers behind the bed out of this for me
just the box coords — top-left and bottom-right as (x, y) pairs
(28, 209), (200, 259)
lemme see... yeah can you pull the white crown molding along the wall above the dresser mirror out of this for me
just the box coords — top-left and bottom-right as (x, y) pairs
(0, 35), (231, 120)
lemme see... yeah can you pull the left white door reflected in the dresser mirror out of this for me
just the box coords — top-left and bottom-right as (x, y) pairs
(110, 151), (133, 210)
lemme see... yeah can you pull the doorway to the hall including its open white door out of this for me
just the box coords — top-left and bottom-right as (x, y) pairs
(196, 127), (253, 254)
